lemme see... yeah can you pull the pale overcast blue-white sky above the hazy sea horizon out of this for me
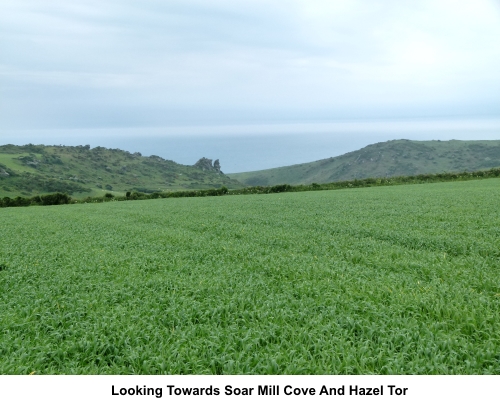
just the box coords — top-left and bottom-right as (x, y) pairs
(0, 0), (500, 133)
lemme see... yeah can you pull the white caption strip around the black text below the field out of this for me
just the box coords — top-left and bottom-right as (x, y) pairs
(0, 375), (500, 405)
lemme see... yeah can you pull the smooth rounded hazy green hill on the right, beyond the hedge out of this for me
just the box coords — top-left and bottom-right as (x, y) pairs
(228, 139), (500, 186)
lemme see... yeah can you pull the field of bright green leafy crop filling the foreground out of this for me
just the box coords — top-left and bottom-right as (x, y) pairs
(0, 179), (500, 374)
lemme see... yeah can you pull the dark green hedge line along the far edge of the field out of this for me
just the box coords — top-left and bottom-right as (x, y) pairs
(0, 168), (500, 208)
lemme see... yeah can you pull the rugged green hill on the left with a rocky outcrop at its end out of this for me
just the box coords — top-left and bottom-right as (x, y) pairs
(0, 145), (243, 197)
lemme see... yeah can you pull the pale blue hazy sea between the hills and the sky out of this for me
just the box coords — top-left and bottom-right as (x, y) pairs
(0, 117), (500, 173)
